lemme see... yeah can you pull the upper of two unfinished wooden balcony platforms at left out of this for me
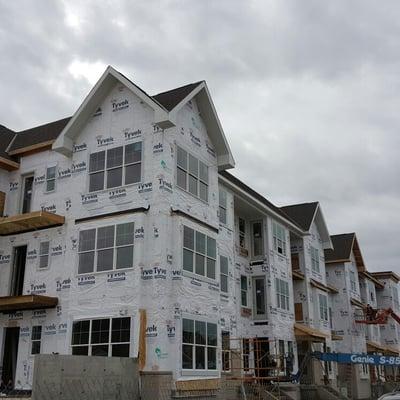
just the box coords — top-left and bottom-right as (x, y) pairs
(0, 211), (65, 236)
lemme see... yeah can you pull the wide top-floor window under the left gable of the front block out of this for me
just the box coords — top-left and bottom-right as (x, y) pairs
(89, 142), (142, 192)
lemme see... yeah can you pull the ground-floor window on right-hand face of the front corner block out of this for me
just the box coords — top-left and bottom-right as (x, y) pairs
(182, 318), (217, 370)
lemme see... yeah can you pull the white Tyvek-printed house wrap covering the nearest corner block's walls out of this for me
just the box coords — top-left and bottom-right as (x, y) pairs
(0, 85), (234, 389)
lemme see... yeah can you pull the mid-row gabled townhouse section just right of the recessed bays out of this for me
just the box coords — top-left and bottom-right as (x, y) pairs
(281, 202), (341, 386)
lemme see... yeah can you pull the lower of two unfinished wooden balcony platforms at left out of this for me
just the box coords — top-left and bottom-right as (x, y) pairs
(0, 294), (58, 313)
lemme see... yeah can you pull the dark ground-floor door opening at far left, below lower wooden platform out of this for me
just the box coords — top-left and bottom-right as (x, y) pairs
(1, 327), (19, 389)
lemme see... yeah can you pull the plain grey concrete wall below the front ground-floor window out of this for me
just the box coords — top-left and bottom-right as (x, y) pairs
(32, 354), (139, 400)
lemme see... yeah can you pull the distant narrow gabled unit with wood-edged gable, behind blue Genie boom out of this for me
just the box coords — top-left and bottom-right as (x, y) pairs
(325, 233), (371, 399)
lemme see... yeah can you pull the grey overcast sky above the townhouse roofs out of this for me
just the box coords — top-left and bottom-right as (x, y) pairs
(0, 0), (400, 273)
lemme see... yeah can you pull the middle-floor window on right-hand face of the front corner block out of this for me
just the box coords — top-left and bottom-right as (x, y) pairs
(183, 226), (217, 279)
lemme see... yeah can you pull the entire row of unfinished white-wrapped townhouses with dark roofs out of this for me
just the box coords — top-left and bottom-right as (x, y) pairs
(0, 67), (399, 398)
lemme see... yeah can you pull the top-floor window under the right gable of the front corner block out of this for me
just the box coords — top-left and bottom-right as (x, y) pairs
(176, 147), (208, 201)
